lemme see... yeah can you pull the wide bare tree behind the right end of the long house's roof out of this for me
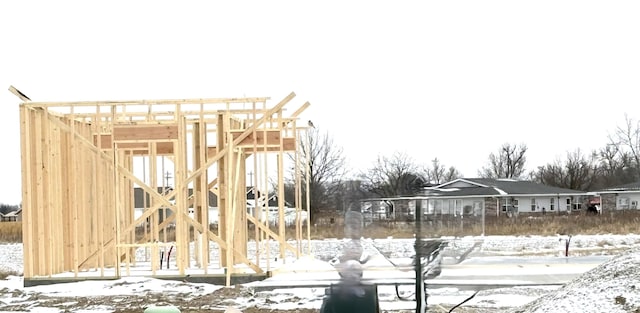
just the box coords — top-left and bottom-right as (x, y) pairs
(533, 149), (601, 191)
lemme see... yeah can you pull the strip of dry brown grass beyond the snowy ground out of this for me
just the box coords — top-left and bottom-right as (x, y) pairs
(0, 210), (640, 243)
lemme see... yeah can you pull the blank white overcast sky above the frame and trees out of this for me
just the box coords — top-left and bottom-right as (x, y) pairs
(0, 0), (640, 204)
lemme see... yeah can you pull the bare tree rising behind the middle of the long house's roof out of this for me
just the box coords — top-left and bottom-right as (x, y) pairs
(478, 143), (527, 179)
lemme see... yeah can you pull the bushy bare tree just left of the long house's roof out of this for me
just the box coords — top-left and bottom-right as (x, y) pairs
(361, 152), (424, 197)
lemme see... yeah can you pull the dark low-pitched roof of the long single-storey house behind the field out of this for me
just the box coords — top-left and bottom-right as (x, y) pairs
(436, 178), (585, 196)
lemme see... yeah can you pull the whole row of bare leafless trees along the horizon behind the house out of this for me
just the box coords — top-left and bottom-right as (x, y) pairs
(286, 116), (640, 219)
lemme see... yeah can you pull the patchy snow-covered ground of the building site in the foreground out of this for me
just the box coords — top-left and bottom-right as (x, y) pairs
(0, 234), (640, 312)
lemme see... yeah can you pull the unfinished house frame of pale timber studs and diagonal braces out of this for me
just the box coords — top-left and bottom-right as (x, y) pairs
(20, 92), (309, 284)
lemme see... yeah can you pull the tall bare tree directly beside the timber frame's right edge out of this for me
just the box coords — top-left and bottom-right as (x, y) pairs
(286, 128), (346, 216)
